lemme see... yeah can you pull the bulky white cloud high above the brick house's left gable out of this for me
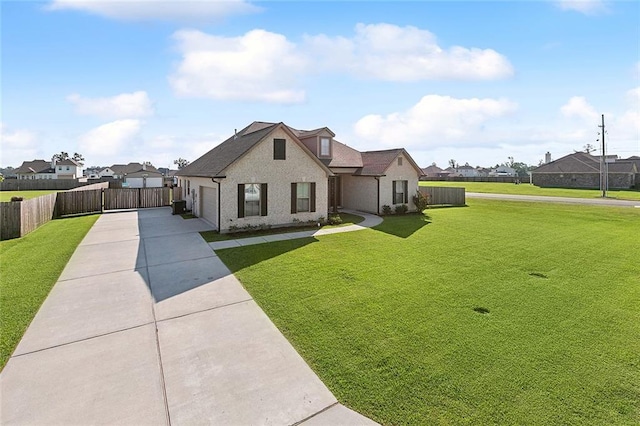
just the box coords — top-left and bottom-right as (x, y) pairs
(169, 30), (305, 103)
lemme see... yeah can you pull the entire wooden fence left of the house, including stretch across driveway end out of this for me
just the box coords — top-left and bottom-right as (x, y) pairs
(0, 187), (171, 240)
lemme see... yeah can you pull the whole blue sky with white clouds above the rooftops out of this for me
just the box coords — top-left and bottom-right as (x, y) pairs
(0, 0), (640, 167)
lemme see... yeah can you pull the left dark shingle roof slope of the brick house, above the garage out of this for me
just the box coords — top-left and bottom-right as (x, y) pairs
(176, 121), (280, 177)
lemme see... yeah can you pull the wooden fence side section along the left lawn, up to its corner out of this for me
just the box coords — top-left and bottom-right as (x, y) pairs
(0, 193), (57, 240)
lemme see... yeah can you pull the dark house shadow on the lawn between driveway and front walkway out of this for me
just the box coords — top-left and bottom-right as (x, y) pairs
(216, 237), (318, 273)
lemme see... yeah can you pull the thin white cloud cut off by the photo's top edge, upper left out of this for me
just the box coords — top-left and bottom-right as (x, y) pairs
(46, 0), (261, 22)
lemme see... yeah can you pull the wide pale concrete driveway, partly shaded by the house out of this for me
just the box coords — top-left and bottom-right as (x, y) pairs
(0, 208), (375, 425)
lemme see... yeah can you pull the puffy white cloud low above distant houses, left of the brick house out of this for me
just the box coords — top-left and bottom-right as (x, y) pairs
(78, 119), (141, 164)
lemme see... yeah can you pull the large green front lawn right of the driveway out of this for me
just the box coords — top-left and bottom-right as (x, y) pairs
(218, 199), (640, 425)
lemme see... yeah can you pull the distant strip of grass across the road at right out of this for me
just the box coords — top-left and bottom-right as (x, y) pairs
(420, 181), (640, 200)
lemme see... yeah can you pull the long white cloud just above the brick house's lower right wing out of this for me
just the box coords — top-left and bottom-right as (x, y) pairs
(354, 95), (517, 149)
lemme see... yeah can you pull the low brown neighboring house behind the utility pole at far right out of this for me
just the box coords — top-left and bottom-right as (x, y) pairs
(531, 152), (640, 189)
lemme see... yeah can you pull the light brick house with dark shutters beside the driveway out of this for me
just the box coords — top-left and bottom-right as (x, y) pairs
(176, 122), (422, 232)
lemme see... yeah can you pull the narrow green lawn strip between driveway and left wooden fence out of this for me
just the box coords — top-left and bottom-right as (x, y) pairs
(0, 215), (99, 369)
